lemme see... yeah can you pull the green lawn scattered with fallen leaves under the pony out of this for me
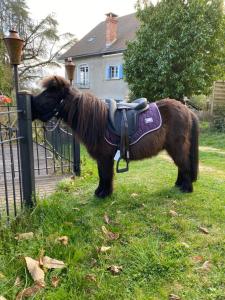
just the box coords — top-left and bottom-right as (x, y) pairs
(0, 123), (225, 300)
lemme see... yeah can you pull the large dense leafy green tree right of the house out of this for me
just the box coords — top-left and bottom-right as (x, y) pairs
(124, 0), (225, 101)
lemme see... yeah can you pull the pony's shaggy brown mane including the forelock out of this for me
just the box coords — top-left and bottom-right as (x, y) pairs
(42, 76), (108, 150)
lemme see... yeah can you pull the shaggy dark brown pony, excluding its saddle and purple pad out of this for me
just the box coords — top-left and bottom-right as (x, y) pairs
(32, 76), (199, 198)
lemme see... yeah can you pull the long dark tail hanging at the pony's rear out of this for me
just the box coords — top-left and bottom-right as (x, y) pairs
(189, 114), (199, 182)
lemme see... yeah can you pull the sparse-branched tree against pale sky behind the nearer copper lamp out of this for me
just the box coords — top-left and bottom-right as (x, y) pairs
(0, 0), (75, 87)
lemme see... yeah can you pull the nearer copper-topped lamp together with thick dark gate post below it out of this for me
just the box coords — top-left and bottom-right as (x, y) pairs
(4, 29), (35, 207)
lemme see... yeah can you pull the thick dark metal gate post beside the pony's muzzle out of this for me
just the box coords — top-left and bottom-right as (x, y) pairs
(17, 92), (35, 207)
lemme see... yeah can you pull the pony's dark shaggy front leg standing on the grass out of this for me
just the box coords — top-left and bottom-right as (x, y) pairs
(95, 157), (114, 198)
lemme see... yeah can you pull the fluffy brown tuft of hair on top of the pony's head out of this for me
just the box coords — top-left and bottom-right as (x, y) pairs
(42, 76), (70, 91)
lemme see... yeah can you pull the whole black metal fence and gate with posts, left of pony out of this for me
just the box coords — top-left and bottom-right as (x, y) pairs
(0, 93), (80, 220)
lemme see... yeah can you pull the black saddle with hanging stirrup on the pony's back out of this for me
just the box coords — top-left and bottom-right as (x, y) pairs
(105, 98), (148, 173)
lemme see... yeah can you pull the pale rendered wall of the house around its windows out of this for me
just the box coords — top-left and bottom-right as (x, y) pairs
(71, 53), (129, 99)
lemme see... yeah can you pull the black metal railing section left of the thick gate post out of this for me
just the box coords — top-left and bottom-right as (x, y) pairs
(0, 106), (24, 219)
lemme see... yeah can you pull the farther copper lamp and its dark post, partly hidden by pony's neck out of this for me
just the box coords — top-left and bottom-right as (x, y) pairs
(65, 58), (80, 176)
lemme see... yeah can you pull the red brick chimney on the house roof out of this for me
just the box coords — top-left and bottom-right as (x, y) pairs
(105, 12), (118, 47)
